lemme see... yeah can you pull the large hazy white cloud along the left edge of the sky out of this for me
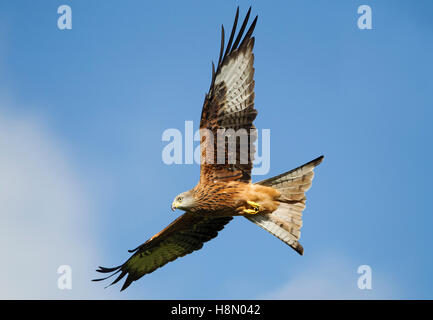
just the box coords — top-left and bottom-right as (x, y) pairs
(0, 104), (113, 299)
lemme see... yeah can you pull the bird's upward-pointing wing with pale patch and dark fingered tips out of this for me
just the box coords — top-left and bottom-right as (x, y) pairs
(200, 8), (257, 184)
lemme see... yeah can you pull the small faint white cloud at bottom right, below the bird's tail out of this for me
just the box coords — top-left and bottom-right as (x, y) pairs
(261, 254), (401, 300)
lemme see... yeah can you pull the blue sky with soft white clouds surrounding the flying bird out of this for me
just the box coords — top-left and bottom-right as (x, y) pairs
(0, 0), (433, 299)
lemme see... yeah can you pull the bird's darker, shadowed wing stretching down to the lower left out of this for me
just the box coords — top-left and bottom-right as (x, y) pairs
(93, 213), (232, 290)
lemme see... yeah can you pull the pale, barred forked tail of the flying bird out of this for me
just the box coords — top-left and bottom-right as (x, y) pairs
(245, 156), (323, 255)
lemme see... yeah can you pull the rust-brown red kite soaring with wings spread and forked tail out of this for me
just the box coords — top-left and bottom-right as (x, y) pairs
(94, 8), (323, 290)
